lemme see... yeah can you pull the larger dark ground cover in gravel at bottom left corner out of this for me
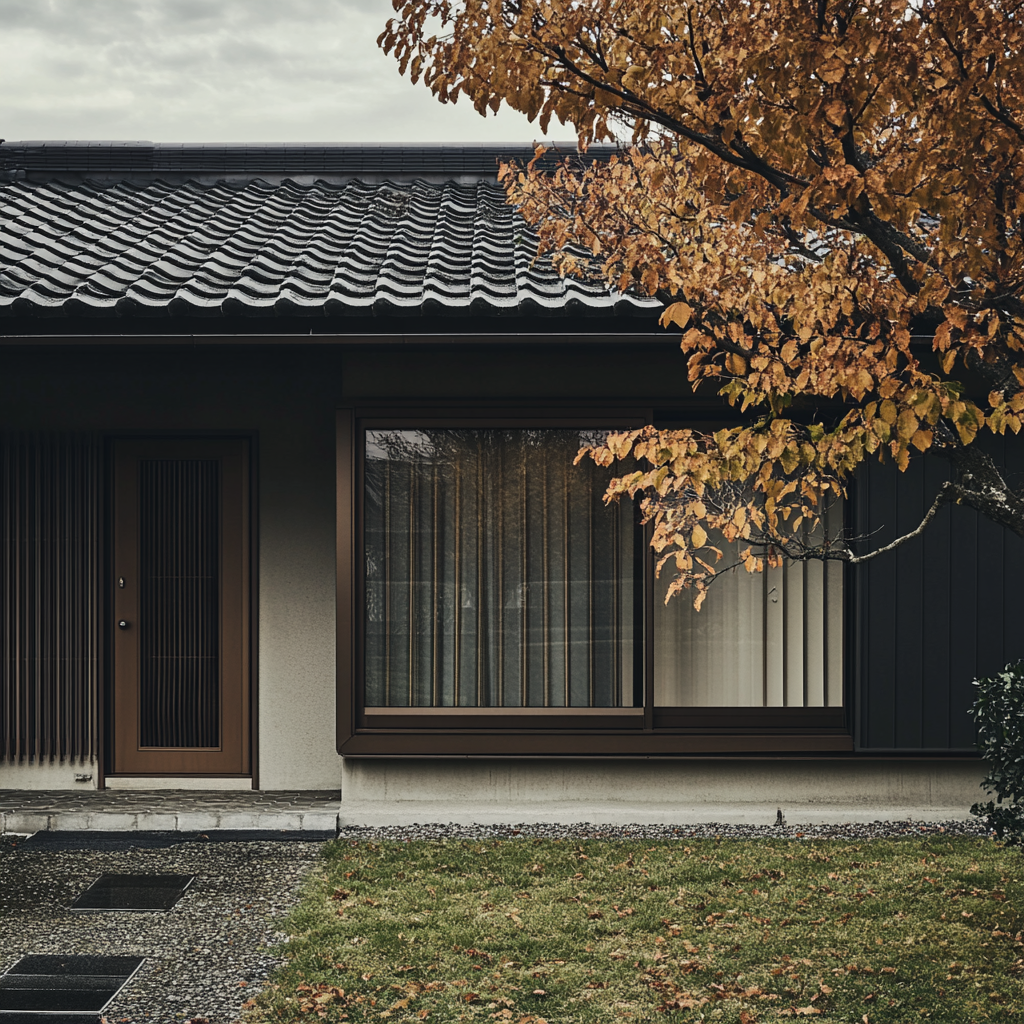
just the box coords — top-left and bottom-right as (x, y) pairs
(0, 954), (143, 1022)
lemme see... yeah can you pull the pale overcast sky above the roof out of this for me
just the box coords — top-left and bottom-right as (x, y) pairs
(0, 0), (544, 142)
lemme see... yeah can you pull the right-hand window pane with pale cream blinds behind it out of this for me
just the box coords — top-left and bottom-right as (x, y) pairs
(654, 508), (843, 708)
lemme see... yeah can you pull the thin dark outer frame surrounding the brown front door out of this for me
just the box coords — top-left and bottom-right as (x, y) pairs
(96, 429), (259, 790)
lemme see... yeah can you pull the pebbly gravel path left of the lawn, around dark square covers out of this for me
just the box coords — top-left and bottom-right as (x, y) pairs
(0, 837), (322, 1024)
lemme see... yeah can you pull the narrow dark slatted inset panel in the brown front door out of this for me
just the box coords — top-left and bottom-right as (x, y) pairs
(139, 459), (220, 748)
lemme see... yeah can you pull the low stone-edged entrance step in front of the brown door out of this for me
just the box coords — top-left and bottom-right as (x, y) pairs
(0, 790), (341, 835)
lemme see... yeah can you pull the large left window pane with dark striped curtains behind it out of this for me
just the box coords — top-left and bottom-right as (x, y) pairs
(365, 428), (639, 708)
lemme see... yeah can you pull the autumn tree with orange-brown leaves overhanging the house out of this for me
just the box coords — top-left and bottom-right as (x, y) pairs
(379, 0), (1024, 607)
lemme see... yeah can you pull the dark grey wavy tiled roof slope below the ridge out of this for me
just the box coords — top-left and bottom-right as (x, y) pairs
(0, 144), (657, 316)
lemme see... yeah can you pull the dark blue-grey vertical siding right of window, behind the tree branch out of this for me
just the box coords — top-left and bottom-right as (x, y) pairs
(850, 436), (1024, 752)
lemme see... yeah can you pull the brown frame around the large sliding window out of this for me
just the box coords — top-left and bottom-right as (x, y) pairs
(336, 401), (853, 757)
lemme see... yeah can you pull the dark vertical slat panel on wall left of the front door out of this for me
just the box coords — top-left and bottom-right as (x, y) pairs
(0, 432), (99, 762)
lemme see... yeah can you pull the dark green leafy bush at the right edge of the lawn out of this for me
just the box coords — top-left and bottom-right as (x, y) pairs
(971, 662), (1024, 846)
